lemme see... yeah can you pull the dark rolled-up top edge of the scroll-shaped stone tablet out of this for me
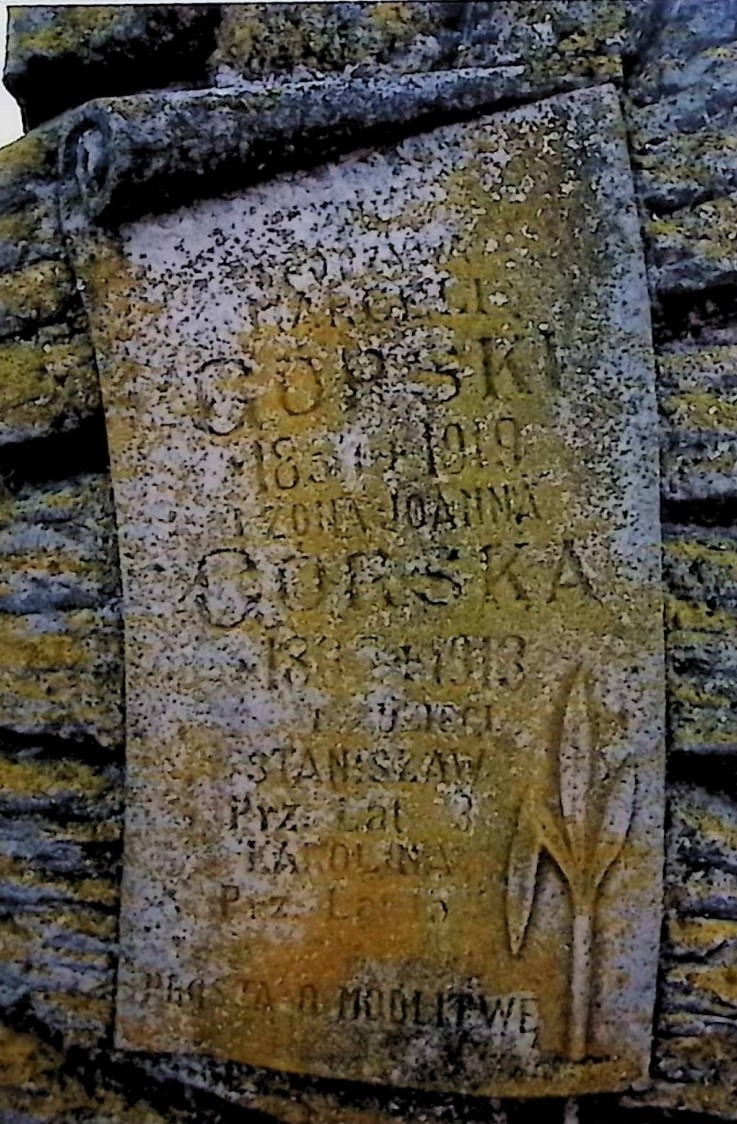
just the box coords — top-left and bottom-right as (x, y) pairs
(62, 66), (597, 230)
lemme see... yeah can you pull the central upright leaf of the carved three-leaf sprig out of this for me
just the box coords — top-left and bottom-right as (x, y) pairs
(558, 668), (594, 867)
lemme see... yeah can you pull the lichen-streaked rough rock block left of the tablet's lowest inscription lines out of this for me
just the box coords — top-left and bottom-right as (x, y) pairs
(0, 731), (122, 1048)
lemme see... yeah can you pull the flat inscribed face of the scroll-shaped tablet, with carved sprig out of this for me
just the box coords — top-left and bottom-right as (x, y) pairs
(79, 90), (663, 1096)
